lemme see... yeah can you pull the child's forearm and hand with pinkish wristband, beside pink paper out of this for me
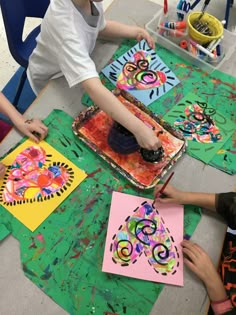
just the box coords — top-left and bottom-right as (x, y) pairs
(181, 240), (233, 314)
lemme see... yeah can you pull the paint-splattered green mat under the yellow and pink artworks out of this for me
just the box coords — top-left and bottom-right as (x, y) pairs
(0, 110), (200, 315)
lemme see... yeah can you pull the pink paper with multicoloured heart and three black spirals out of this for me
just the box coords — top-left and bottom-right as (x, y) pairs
(102, 192), (183, 286)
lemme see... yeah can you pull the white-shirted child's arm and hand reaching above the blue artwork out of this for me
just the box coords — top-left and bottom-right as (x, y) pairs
(99, 21), (155, 48)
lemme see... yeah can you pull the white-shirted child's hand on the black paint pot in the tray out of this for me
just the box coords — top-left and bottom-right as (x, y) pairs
(134, 125), (161, 150)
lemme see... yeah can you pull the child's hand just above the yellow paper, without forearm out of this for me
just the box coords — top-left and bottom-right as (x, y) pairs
(14, 118), (48, 143)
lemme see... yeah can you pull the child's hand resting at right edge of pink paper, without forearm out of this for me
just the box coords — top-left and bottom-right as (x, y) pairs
(181, 240), (219, 286)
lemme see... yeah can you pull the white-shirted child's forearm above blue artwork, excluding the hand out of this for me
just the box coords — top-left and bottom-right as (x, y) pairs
(99, 21), (139, 38)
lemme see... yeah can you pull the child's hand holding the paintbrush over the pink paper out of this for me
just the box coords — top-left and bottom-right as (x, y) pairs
(154, 184), (184, 205)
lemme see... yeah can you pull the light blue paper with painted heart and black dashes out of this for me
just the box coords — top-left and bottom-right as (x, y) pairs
(102, 40), (179, 106)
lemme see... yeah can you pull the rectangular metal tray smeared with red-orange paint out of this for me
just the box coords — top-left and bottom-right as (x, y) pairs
(72, 90), (186, 189)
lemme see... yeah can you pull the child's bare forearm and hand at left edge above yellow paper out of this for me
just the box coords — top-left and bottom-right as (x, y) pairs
(0, 92), (48, 143)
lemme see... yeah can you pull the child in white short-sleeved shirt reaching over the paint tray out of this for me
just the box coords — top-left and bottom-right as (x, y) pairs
(27, 0), (161, 150)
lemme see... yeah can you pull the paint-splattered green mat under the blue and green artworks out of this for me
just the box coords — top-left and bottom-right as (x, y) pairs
(82, 40), (236, 174)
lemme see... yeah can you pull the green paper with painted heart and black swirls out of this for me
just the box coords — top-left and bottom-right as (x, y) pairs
(163, 93), (235, 164)
